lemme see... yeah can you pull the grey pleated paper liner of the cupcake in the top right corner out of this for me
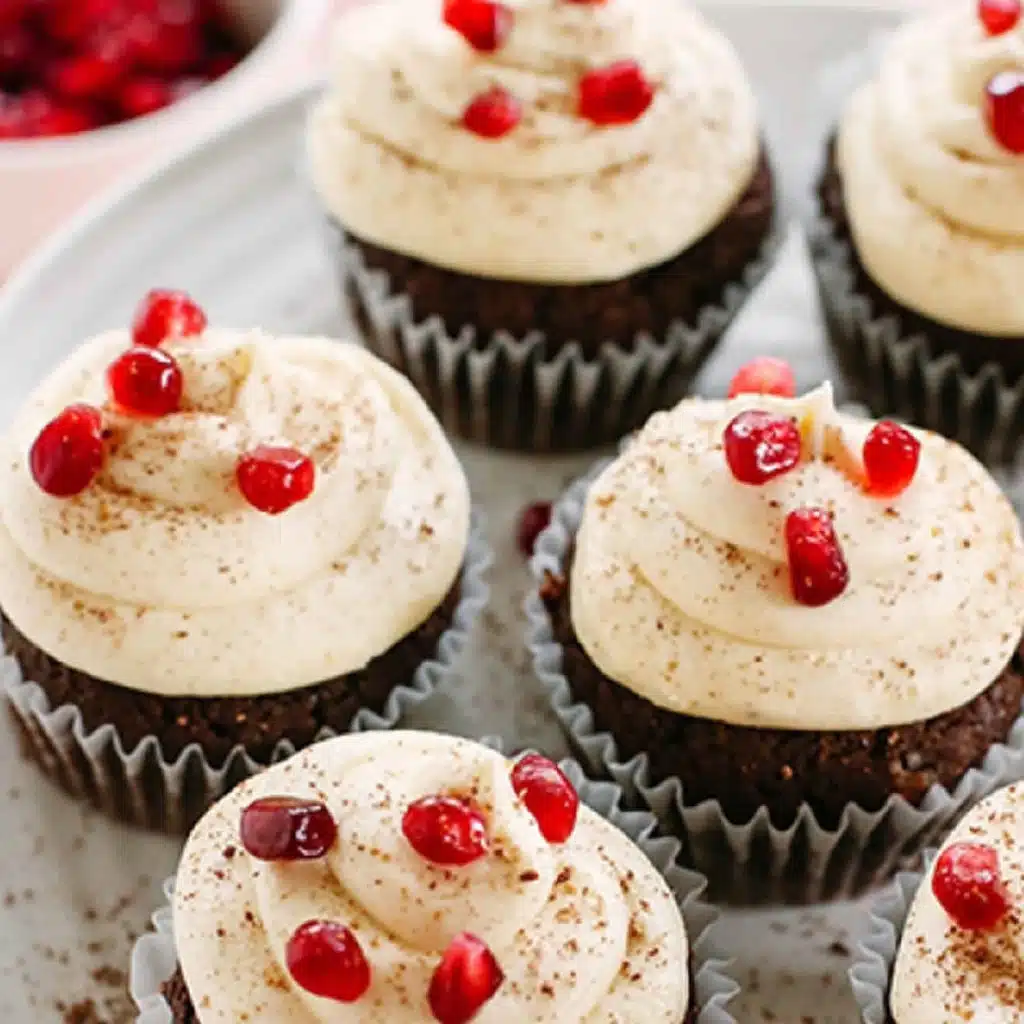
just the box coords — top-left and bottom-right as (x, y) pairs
(808, 216), (1024, 466)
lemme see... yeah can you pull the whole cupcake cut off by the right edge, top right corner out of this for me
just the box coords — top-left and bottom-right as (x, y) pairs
(813, 0), (1024, 463)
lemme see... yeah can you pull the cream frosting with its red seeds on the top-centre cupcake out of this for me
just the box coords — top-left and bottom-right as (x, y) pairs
(309, 0), (760, 284)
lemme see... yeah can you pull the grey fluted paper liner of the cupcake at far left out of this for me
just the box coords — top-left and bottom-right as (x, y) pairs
(0, 517), (492, 835)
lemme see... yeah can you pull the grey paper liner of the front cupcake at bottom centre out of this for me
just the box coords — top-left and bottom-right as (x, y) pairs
(131, 761), (739, 1024)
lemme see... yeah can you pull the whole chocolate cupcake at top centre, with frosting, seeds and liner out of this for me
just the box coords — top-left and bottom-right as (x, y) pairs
(308, 0), (774, 451)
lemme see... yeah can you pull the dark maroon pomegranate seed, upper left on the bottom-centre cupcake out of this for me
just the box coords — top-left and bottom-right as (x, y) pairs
(242, 797), (338, 860)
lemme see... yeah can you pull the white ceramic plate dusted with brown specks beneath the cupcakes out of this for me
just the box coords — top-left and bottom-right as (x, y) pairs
(0, 2), (913, 1024)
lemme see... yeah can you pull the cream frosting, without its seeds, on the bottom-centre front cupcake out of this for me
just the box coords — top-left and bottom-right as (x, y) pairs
(174, 732), (689, 1024)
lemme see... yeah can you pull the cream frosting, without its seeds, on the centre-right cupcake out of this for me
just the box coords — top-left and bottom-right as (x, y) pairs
(570, 386), (1024, 729)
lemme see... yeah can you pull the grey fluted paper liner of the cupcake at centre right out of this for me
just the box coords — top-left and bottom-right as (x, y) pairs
(525, 461), (1024, 905)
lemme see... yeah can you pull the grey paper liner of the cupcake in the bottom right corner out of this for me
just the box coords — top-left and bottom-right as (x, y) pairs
(850, 850), (936, 1024)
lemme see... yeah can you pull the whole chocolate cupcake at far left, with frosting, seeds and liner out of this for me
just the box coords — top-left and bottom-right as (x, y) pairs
(0, 293), (486, 830)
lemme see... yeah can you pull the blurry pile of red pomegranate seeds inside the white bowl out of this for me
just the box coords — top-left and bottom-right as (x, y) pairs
(0, 0), (245, 139)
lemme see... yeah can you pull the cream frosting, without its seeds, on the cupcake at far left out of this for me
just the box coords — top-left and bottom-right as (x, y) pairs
(0, 330), (469, 696)
